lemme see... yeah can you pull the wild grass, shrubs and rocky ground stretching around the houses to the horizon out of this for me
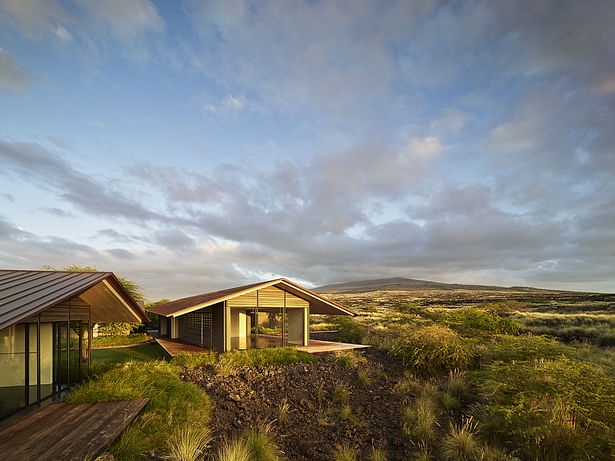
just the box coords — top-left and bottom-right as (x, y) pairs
(69, 279), (615, 461)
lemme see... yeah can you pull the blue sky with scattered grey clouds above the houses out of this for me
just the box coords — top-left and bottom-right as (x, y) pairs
(0, 0), (615, 300)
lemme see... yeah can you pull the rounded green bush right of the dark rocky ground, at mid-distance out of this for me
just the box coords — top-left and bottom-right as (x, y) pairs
(391, 325), (475, 375)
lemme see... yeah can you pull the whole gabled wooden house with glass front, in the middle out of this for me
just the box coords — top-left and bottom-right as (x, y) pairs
(149, 278), (356, 352)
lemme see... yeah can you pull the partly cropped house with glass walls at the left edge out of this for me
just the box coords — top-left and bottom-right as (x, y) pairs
(0, 270), (149, 418)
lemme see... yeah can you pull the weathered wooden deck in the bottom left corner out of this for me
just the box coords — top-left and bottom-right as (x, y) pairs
(0, 399), (149, 461)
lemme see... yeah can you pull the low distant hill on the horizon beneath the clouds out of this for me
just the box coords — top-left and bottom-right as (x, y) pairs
(313, 277), (564, 294)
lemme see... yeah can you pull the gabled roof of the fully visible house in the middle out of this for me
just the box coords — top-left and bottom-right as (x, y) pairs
(149, 278), (357, 317)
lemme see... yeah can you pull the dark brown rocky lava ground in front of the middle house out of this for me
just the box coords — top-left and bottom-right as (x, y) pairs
(181, 349), (411, 461)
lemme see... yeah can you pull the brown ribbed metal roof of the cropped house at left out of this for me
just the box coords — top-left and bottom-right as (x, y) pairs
(0, 270), (149, 330)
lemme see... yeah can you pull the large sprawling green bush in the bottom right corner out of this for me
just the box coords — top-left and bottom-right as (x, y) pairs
(473, 356), (615, 460)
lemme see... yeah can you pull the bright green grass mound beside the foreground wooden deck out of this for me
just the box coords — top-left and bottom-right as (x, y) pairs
(67, 360), (210, 461)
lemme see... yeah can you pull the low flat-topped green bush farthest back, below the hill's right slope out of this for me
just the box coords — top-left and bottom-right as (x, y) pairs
(443, 307), (520, 335)
